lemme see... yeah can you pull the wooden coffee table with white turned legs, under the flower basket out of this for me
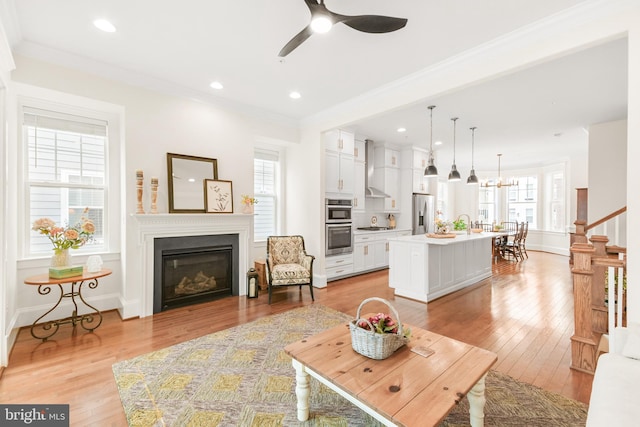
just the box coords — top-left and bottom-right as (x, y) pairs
(285, 323), (498, 427)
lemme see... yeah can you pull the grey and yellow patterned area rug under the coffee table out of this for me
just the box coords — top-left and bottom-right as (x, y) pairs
(113, 304), (587, 427)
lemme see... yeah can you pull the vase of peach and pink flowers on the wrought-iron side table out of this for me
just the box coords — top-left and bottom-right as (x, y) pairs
(31, 209), (96, 267)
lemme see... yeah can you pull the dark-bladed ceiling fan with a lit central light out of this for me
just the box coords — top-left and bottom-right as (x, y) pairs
(278, 0), (407, 57)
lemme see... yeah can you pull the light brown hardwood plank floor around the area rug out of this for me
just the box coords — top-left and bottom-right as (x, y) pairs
(0, 251), (592, 426)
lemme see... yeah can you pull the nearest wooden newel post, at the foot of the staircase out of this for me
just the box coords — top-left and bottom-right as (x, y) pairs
(571, 243), (598, 374)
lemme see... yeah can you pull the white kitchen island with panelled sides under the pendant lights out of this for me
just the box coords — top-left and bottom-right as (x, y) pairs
(389, 233), (498, 302)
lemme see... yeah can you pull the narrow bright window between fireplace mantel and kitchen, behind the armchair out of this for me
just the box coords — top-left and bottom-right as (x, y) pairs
(253, 150), (280, 242)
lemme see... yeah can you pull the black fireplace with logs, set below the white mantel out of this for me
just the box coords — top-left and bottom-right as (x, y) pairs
(153, 234), (239, 313)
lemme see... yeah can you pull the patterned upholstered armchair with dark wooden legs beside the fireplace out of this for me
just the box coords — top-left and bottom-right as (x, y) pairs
(267, 236), (315, 304)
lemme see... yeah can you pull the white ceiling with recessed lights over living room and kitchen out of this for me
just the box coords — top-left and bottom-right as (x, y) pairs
(0, 0), (627, 175)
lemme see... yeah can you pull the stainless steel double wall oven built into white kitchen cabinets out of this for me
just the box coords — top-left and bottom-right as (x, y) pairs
(325, 199), (353, 255)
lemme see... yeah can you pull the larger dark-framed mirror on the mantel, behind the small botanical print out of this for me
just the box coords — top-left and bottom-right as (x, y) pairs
(167, 153), (218, 213)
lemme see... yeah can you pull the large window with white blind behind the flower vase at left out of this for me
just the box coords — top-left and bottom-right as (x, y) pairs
(23, 107), (108, 255)
